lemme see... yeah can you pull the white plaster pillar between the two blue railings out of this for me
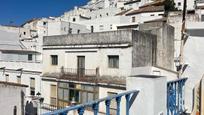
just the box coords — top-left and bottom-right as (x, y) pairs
(126, 75), (167, 115)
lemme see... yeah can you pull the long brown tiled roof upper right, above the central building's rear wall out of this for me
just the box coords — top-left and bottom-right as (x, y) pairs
(126, 6), (164, 15)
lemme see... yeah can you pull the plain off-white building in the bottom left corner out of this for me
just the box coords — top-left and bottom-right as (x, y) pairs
(0, 81), (28, 115)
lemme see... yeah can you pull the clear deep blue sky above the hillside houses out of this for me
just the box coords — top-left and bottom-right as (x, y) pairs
(0, 0), (89, 26)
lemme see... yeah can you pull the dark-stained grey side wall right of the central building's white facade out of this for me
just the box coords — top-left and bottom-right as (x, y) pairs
(132, 31), (156, 67)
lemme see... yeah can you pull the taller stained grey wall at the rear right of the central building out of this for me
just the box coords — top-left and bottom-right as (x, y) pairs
(139, 22), (174, 70)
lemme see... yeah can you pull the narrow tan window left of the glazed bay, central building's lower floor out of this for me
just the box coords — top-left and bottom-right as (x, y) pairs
(50, 85), (57, 106)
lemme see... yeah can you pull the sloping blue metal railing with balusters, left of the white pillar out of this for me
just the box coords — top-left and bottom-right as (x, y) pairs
(43, 90), (139, 115)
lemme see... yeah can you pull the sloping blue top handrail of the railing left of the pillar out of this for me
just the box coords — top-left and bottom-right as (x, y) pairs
(43, 90), (139, 115)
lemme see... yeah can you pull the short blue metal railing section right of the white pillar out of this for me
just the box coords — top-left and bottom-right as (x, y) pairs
(167, 78), (187, 115)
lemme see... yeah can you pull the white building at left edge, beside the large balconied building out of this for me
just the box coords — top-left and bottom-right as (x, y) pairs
(0, 31), (42, 96)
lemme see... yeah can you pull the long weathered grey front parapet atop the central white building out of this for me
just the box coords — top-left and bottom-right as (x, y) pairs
(43, 30), (132, 46)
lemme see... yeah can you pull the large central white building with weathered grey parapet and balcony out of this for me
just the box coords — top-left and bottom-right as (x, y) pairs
(42, 26), (177, 113)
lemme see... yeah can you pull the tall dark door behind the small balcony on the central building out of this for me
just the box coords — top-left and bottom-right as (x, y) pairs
(77, 56), (85, 77)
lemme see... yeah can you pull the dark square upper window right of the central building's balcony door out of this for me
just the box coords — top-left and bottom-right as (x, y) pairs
(108, 55), (119, 68)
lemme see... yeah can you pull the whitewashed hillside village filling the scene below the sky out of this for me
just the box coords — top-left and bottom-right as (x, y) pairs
(0, 0), (204, 115)
